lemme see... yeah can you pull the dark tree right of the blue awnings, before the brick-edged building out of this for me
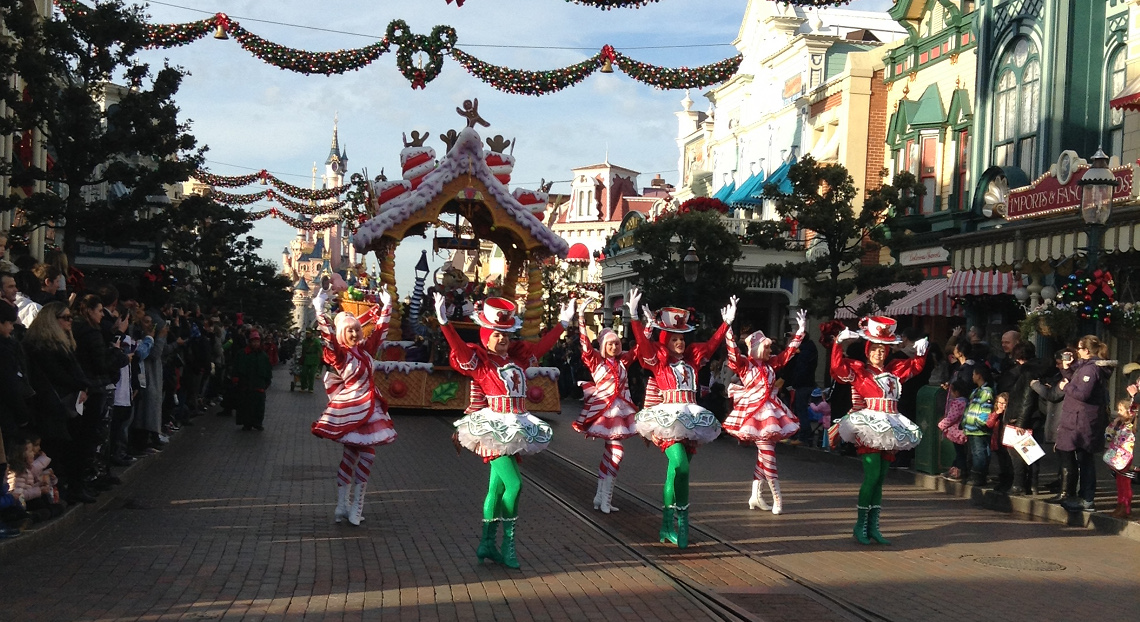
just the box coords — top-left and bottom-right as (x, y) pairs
(747, 156), (926, 318)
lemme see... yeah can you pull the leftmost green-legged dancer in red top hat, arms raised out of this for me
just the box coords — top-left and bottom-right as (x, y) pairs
(435, 294), (575, 568)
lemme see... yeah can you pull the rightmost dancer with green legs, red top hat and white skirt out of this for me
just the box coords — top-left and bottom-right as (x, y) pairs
(831, 317), (929, 545)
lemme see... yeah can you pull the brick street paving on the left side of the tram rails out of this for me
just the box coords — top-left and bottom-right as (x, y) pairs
(0, 370), (707, 621)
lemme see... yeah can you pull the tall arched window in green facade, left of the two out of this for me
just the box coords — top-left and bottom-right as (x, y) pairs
(993, 36), (1041, 177)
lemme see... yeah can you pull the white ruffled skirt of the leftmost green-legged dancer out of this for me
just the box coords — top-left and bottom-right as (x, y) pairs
(455, 408), (554, 458)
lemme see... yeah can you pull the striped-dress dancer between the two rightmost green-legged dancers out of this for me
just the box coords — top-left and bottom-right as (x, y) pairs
(724, 303), (807, 514)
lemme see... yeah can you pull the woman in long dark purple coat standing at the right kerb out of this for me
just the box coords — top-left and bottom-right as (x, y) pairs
(1056, 335), (1116, 511)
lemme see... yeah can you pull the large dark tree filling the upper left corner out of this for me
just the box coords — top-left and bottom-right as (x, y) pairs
(0, 0), (202, 260)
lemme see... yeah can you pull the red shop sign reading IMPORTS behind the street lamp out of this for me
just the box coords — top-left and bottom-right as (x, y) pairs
(1005, 152), (1133, 220)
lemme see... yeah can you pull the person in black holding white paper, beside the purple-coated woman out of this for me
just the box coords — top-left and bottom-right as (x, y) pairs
(1004, 342), (1049, 494)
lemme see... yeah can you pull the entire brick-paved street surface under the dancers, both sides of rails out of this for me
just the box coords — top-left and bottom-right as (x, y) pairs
(0, 371), (1140, 622)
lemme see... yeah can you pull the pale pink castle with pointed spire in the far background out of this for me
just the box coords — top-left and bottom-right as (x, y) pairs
(282, 120), (364, 328)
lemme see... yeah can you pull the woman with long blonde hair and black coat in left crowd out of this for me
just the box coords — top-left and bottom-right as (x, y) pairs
(23, 302), (95, 504)
